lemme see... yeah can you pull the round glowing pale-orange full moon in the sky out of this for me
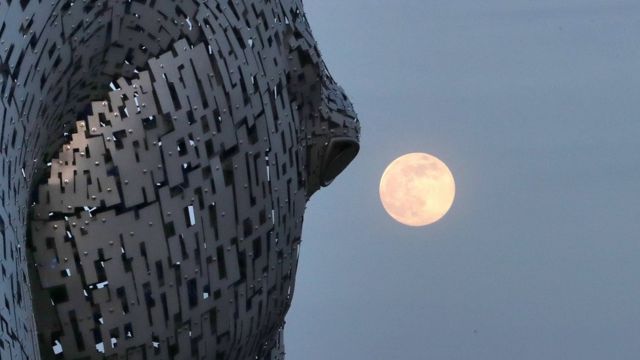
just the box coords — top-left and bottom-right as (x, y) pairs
(380, 153), (456, 227)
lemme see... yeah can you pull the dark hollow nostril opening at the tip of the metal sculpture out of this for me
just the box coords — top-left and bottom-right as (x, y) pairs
(320, 137), (360, 186)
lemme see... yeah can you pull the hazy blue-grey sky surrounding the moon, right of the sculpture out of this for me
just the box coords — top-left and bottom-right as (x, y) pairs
(286, 0), (640, 360)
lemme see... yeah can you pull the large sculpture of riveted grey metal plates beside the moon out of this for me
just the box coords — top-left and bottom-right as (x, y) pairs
(0, 0), (359, 359)
